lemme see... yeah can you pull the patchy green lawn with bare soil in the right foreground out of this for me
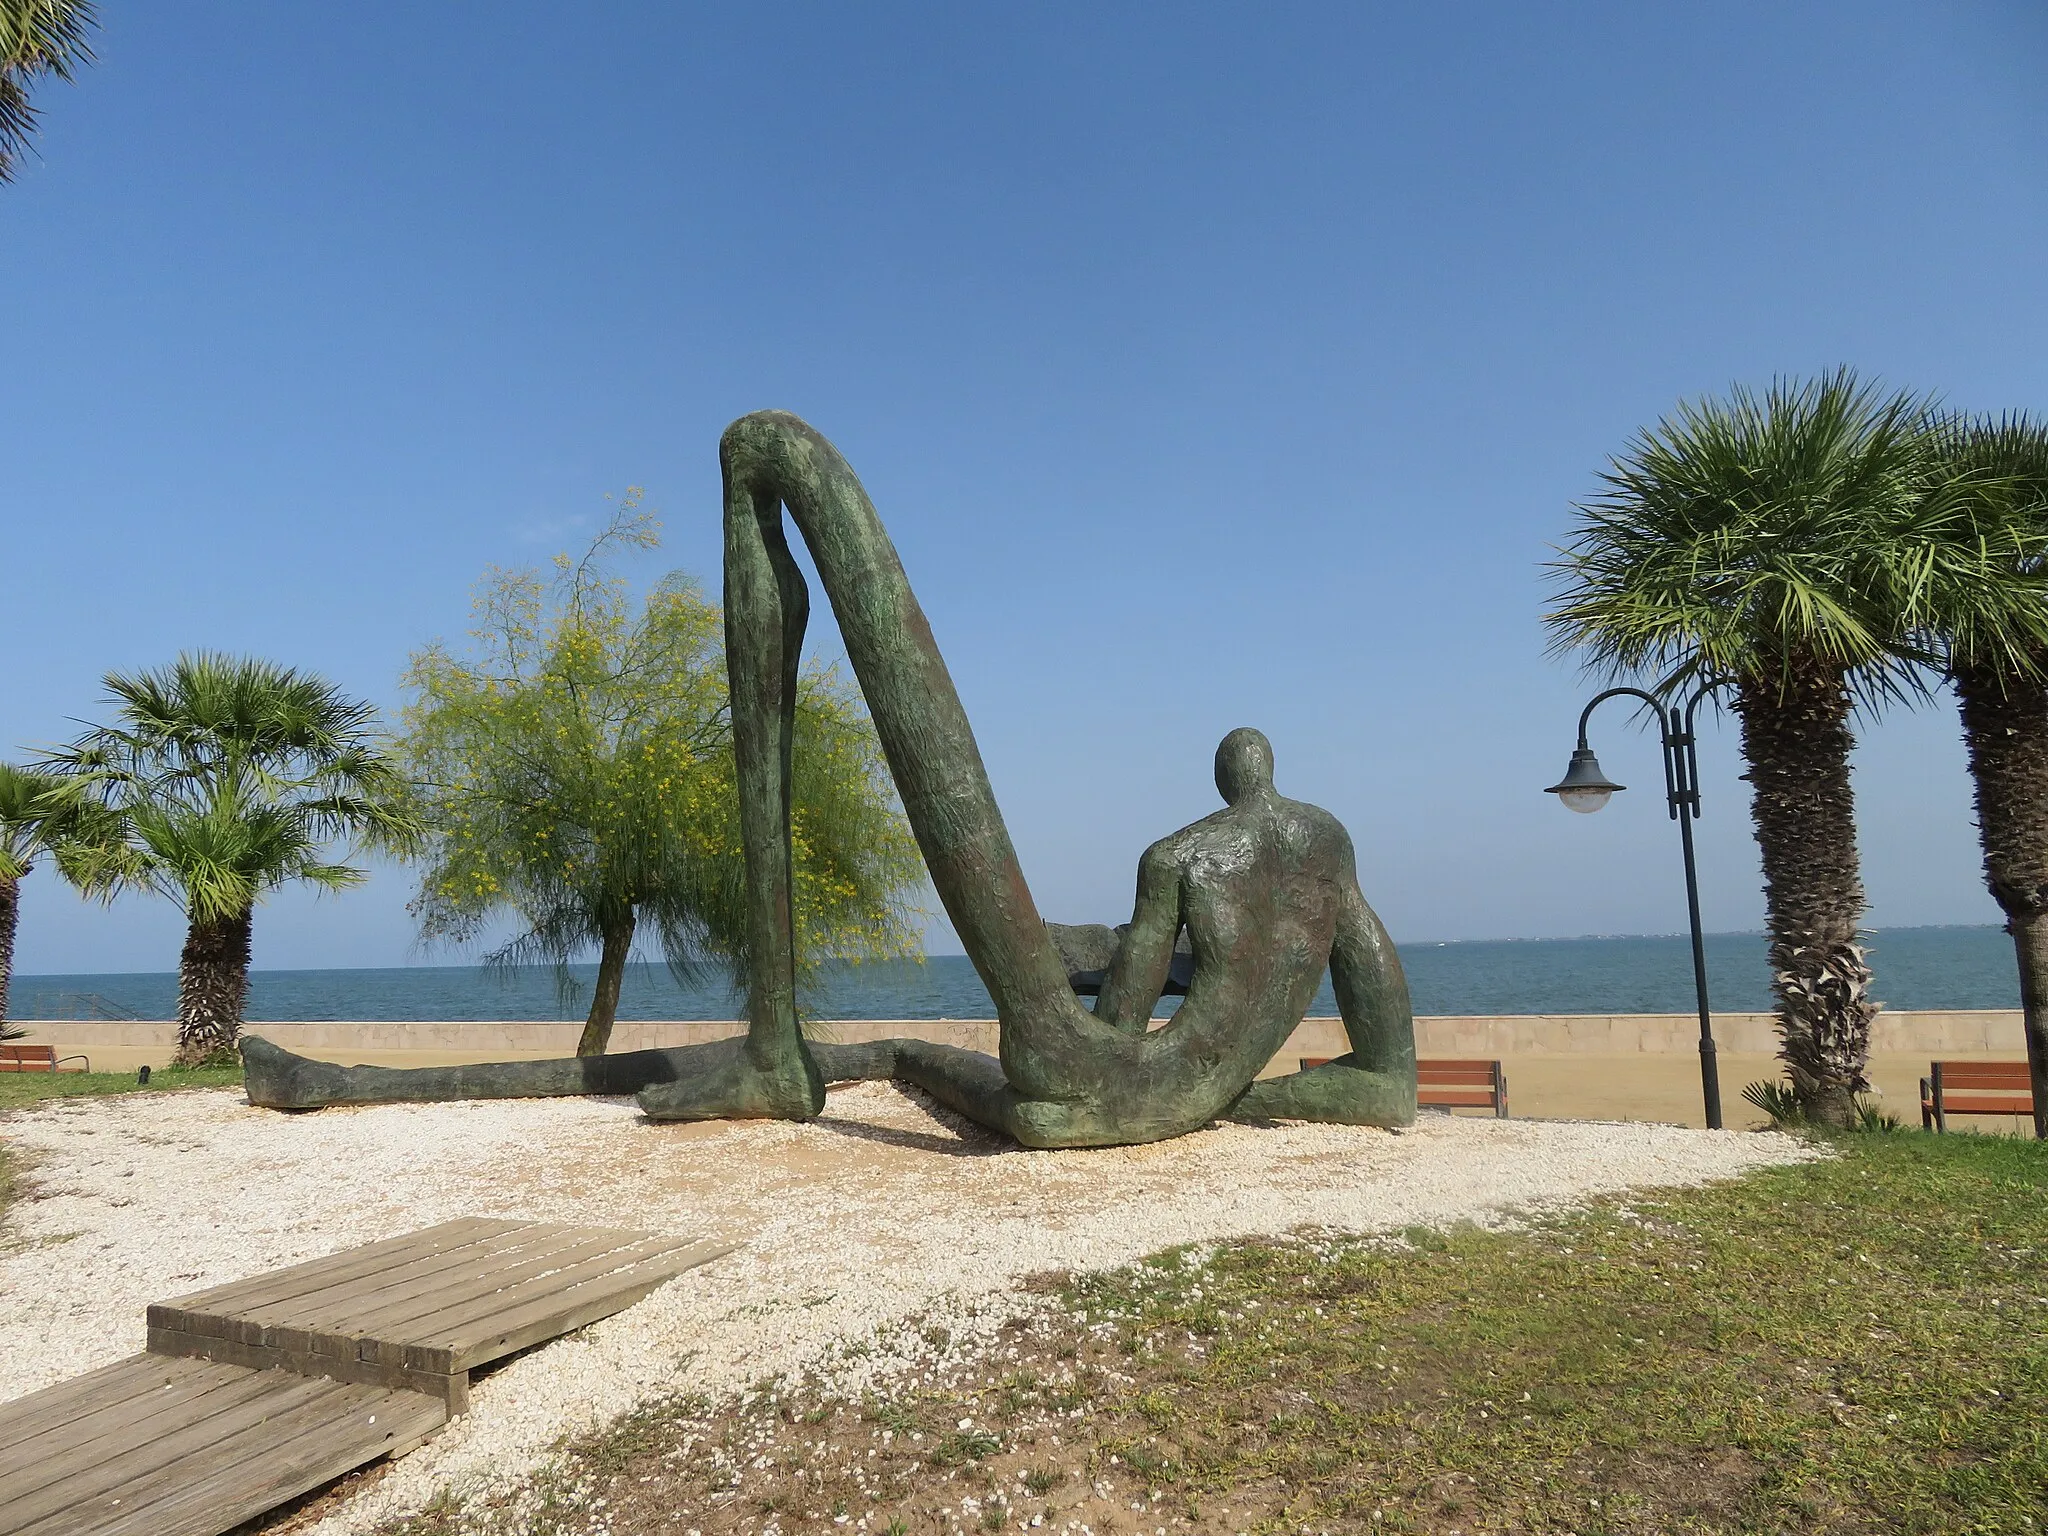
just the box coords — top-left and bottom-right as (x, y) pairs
(393, 1133), (2048, 1536)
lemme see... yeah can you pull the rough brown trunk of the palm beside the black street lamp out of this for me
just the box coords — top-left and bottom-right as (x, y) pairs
(1735, 657), (1876, 1126)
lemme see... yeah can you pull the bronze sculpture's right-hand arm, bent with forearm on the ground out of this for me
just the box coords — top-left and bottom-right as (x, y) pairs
(1227, 883), (1415, 1126)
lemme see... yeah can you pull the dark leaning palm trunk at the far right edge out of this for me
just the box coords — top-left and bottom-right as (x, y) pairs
(1956, 657), (2048, 1137)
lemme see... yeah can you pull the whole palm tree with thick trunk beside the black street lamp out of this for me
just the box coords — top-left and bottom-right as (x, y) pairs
(1546, 369), (1998, 1124)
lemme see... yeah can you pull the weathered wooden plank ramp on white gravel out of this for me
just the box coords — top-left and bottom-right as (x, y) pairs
(0, 1219), (731, 1536)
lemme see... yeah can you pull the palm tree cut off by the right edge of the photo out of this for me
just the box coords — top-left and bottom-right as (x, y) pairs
(1933, 416), (2048, 1137)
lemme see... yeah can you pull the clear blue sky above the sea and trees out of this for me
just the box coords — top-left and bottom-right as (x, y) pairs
(0, 0), (2048, 973)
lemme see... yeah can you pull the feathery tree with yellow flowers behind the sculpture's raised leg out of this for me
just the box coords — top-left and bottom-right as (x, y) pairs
(401, 501), (924, 1055)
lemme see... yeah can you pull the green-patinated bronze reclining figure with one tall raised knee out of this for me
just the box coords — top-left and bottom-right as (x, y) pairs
(242, 412), (1415, 1147)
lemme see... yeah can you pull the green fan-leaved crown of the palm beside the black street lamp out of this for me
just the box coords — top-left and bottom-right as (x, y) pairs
(1544, 369), (1987, 705)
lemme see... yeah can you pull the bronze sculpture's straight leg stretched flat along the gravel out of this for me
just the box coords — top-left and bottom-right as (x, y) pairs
(242, 1034), (895, 1120)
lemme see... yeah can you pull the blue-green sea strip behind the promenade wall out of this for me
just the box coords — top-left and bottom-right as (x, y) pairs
(8, 928), (2019, 1022)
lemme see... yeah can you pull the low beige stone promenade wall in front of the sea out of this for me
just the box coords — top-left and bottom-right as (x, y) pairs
(14, 1010), (2025, 1057)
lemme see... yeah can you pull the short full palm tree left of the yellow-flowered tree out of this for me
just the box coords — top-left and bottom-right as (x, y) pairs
(49, 653), (416, 1065)
